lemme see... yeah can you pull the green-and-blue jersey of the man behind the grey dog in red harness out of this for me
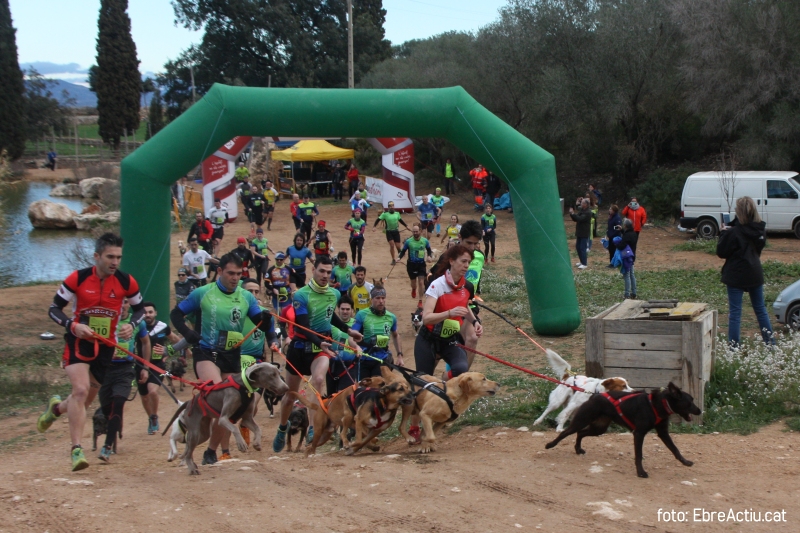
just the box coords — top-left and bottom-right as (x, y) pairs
(178, 280), (261, 351)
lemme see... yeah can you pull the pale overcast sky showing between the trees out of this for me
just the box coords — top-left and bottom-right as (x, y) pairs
(9, 0), (507, 82)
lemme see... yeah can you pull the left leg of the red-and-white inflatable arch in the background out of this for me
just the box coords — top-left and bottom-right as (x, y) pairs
(203, 136), (252, 221)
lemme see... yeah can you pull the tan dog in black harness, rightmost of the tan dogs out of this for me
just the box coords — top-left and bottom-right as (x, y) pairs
(400, 372), (500, 453)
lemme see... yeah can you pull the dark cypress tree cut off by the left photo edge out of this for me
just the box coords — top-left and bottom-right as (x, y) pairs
(0, 0), (25, 159)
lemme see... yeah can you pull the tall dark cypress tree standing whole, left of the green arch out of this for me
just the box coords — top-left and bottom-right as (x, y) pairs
(93, 0), (142, 150)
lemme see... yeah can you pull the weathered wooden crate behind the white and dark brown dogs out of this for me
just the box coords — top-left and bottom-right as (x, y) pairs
(586, 300), (717, 422)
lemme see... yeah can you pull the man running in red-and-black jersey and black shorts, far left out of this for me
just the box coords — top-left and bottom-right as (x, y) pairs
(37, 233), (144, 471)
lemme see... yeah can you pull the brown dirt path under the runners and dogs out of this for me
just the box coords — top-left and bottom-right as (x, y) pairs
(0, 196), (800, 533)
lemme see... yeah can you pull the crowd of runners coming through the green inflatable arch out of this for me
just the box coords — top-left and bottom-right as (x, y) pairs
(38, 167), (497, 470)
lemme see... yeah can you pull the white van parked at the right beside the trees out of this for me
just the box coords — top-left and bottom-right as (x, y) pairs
(680, 171), (800, 239)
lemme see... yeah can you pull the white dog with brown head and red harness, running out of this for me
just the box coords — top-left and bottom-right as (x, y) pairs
(533, 350), (633, 432)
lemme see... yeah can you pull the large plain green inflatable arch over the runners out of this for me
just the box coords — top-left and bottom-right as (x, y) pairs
(121, 84), (580, 335)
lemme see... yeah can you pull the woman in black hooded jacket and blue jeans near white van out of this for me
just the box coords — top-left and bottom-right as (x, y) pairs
(717, 196), (775, 346)
